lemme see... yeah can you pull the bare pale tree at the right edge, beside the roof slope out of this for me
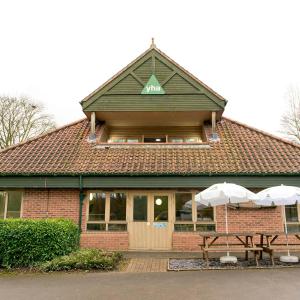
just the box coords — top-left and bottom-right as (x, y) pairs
(281, 87), (300, 143)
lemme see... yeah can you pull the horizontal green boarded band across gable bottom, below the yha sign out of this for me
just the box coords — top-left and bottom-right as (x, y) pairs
(85, 94), (220, 111)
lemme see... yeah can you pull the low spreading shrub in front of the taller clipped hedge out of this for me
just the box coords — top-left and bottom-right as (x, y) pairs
(40, 249), (122, 271)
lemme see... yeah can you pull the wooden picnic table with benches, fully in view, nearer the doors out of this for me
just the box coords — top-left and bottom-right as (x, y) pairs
(200, 232), (263, 266)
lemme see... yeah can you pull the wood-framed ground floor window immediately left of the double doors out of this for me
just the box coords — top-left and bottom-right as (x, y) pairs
(87, 192), (127, 231)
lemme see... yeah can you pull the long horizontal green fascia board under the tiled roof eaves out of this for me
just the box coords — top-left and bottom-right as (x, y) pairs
(0, 174), (300, 189)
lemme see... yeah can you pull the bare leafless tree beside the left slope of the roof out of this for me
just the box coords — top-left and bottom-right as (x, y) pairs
(0, 96), (55, 149)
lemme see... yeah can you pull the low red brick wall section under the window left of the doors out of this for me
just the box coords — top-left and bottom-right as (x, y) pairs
(80, 232), (129, 250)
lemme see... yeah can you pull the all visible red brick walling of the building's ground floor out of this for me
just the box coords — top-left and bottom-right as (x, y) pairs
(22, 189), (290, 251)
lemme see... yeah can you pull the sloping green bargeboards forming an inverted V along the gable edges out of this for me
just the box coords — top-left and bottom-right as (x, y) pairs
(81, 49), (227, 111)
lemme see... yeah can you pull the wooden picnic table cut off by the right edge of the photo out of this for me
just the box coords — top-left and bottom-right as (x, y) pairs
(257, 231), (300, 265)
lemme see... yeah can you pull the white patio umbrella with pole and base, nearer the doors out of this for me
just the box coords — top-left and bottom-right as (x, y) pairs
(195, 182), (258, 263)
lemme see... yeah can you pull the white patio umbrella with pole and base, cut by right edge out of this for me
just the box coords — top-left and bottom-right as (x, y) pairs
(255, 184), (300, 262)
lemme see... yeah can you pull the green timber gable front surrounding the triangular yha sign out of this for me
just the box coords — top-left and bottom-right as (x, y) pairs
(81, 48), (226, 112)
